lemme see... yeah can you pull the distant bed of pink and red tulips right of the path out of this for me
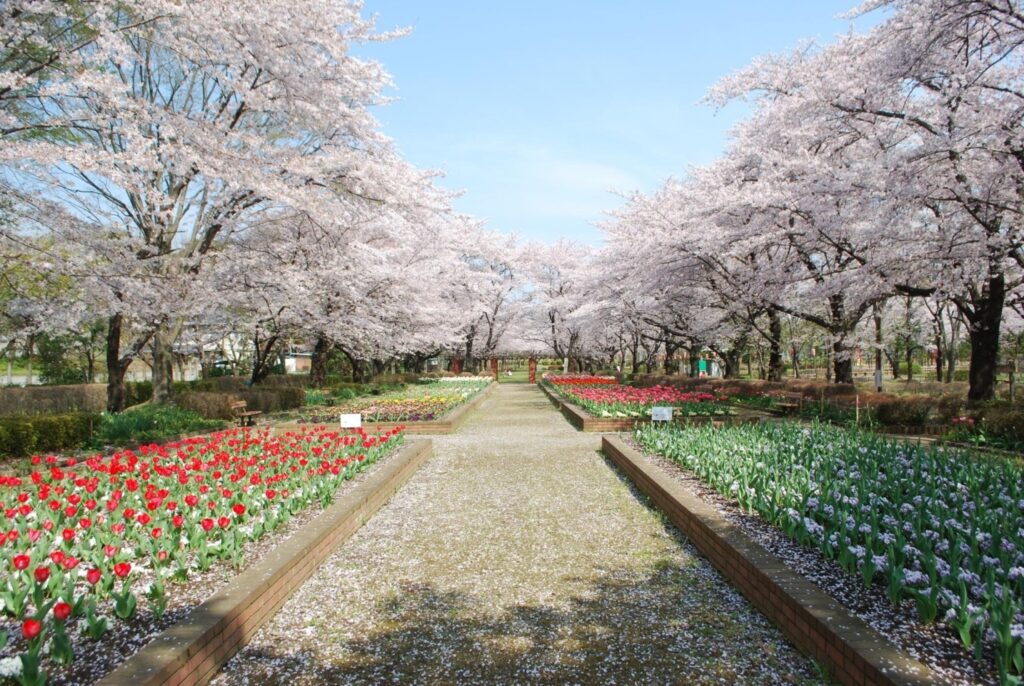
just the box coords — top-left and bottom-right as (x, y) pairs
(545, 376), (732, 419)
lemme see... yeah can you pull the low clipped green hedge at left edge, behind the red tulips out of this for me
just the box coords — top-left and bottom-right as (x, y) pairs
(0, 412), (100, 457)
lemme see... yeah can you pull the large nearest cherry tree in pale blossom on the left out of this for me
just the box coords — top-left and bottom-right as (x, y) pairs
(0, 0), (415, 410)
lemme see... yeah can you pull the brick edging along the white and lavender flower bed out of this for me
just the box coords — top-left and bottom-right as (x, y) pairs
(601, 436), (943, 686)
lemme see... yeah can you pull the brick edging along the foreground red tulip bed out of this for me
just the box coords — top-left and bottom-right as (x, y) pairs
(96, 439), (432, 686)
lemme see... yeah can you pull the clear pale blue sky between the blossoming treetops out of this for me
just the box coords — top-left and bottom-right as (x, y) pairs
(359, 0), (871, 244)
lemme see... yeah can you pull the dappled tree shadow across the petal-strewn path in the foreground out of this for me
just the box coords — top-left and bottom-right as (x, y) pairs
(221, 560), (817, 686)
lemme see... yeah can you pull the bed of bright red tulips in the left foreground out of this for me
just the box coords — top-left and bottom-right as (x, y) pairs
(0, 429), (401, 684)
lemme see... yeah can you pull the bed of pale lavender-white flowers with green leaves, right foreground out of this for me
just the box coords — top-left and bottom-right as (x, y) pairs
(636, 424), (1024, 684)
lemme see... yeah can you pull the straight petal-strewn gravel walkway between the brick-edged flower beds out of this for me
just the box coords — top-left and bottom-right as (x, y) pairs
(215, 385), (818, 685)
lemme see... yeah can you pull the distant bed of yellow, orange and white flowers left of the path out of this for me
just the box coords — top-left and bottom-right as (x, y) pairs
(298, 377), (492, 424)
